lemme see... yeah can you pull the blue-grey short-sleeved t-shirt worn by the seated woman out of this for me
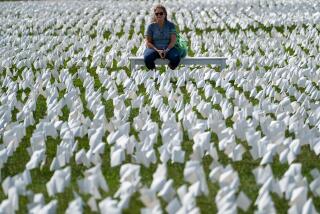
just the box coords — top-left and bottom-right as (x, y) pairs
(144, 21), (176, 49)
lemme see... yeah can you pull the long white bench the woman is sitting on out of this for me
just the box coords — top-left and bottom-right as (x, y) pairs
(129, 57), (227, 70)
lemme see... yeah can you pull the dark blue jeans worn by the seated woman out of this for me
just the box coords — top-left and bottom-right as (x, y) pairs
(143, 48), (181, 70)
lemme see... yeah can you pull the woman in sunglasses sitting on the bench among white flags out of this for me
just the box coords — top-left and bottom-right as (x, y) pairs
(144, 5), (181, 70)
